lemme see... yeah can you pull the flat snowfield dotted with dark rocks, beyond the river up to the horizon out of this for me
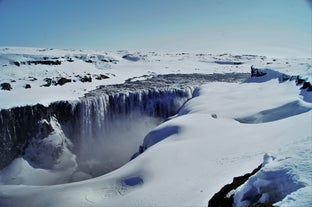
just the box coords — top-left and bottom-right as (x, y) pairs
(0, 47), (312, 109)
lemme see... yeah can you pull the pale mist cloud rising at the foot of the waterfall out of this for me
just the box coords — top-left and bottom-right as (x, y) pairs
(74, 112), (161, 177)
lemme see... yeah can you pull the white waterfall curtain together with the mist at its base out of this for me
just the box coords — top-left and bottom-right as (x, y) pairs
(70, 87), (194, 177)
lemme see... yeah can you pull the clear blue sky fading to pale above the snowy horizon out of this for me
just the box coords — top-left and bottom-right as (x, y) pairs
(0, 0), (312, 57)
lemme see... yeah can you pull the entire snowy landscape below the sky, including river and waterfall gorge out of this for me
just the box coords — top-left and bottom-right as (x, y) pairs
(0, 47), (312, 207)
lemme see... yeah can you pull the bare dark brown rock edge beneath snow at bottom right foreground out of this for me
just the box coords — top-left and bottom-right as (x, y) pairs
(208, 165), (262, 207)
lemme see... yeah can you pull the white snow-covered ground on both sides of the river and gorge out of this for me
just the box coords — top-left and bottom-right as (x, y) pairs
(0, 48), (312, 207)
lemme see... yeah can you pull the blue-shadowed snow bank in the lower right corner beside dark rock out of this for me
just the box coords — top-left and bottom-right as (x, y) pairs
(234, 137), (312, 207)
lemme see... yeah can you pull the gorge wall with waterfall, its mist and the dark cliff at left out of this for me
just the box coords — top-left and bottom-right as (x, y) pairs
(0, 86), (194, 176)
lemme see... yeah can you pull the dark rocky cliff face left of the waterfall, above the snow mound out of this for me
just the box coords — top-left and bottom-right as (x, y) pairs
(0, 102), (78, 169)
